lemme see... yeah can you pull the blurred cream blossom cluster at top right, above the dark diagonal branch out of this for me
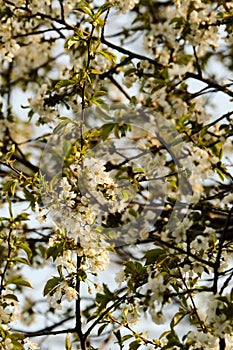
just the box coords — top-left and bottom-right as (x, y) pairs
(145, 1), (221, 65)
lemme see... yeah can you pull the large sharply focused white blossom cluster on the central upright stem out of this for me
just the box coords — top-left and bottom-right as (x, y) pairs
(44, 158), (124, 272)
